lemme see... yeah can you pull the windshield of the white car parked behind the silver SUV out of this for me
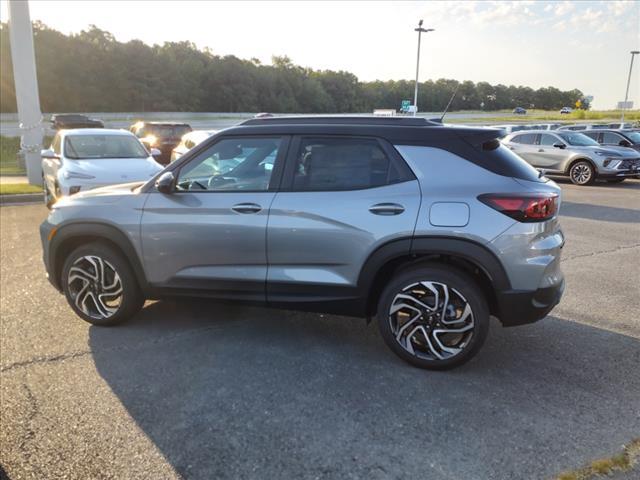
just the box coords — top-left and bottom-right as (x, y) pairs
(64, 135), (149, 159)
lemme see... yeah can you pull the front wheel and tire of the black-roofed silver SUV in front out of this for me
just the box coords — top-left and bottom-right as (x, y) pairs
(61, 242), (145, 326)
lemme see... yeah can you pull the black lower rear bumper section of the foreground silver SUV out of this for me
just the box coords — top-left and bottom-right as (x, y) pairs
(498, 280), (564, 327)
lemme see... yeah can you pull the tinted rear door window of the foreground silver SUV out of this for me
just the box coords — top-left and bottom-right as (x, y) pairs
(293, 138), (399, 191)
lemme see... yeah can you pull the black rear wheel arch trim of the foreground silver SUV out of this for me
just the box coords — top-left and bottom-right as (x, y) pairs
(358, 236), (511, 317)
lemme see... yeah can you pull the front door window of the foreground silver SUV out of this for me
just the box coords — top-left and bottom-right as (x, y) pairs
(177, 137), (282, 191)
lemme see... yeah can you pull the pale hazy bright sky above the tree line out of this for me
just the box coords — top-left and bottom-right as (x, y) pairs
(0, 0), (640, 109)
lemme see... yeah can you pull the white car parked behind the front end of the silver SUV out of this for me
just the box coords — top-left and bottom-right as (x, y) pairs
(42, 129), (162, 207)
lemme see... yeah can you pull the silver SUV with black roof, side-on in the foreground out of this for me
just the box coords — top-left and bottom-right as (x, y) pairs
(41, 117), (564, 369)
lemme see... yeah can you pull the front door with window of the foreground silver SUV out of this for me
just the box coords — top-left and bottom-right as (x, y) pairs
(141, 136), (288, 301)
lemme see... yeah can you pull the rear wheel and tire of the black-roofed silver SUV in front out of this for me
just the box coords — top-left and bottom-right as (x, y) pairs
(377, 264), (489, 370)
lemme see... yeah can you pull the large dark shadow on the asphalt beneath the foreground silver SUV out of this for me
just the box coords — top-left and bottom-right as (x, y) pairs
(90, 300), (640, 479)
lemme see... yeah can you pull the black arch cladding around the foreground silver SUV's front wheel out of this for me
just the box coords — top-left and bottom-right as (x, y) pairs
(49, 222), (148, 292)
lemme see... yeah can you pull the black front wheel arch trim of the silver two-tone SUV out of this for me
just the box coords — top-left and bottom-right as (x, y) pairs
(47, 222), (149, 292)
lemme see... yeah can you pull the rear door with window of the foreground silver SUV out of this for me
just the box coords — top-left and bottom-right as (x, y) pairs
(267, 136), (421, 303)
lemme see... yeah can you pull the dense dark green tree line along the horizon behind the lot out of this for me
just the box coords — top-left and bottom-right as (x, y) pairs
(0, 22), (588, 113)
